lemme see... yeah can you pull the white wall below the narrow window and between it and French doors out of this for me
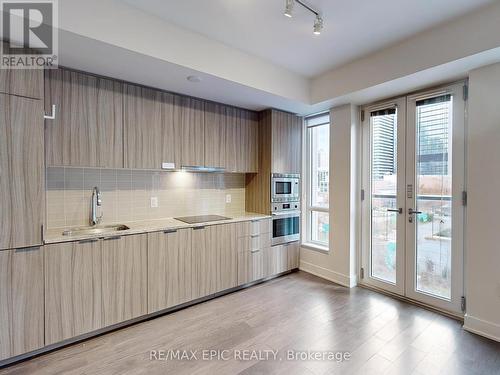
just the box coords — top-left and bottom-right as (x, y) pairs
(300, 104), (360, 287)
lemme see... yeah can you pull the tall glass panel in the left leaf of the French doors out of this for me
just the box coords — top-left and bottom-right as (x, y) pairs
(370, 109), (398, 283)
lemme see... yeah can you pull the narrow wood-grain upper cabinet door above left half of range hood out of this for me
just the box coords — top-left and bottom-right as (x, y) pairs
(179, 96), (205, 166)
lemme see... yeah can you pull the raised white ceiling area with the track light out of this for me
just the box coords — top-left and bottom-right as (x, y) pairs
(122, 0), (497, 77)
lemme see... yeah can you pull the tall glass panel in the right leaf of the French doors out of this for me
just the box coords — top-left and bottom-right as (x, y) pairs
(413, 95), (453, 299)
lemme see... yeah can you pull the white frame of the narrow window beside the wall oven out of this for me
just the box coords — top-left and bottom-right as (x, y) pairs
(302, 112), (331, 252)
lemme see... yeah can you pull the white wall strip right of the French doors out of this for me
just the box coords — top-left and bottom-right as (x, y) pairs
(464, 64), (500, 341)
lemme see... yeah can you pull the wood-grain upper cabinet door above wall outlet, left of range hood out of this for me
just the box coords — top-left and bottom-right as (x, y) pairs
(124, 84), (181, 169)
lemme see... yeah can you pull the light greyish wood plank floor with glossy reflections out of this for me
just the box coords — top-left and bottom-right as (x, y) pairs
(0, 272), (500, 375)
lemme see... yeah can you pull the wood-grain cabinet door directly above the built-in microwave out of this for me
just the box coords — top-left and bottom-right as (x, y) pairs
(271, 110), (302, 173)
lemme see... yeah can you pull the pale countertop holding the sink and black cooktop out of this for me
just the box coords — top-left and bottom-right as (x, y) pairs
(44, 212), (271, 244)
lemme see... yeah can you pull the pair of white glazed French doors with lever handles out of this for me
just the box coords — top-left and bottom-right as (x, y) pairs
(361, 83), (465, 314)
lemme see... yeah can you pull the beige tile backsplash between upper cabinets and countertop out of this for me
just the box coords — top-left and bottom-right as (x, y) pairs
(46, 167), (245, 229)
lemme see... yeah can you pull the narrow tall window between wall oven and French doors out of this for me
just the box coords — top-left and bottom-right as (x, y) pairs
(305, 113), (330, 249)
